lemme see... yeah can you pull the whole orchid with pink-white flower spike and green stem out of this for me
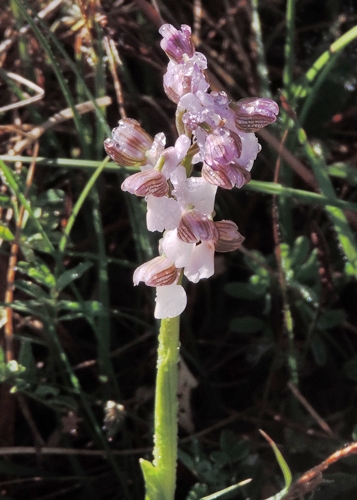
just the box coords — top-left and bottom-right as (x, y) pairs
(104, 24), (279, 500)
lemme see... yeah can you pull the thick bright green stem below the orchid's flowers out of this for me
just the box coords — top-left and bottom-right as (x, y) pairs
(153, 316), (180, 500)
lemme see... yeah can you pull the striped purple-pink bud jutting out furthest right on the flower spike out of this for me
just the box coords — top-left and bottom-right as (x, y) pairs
(232, 97), (279, 132)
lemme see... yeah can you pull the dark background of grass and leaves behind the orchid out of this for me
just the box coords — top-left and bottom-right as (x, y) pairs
(0, 0), (357, 500)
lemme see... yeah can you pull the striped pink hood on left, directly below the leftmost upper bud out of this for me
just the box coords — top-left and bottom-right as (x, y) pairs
(121, 168), (169, 198)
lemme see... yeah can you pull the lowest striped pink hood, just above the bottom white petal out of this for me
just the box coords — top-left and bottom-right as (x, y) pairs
(133, 255), (180, 286)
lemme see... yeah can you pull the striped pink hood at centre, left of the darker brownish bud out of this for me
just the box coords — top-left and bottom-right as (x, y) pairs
(177, 210), (219, 243)
